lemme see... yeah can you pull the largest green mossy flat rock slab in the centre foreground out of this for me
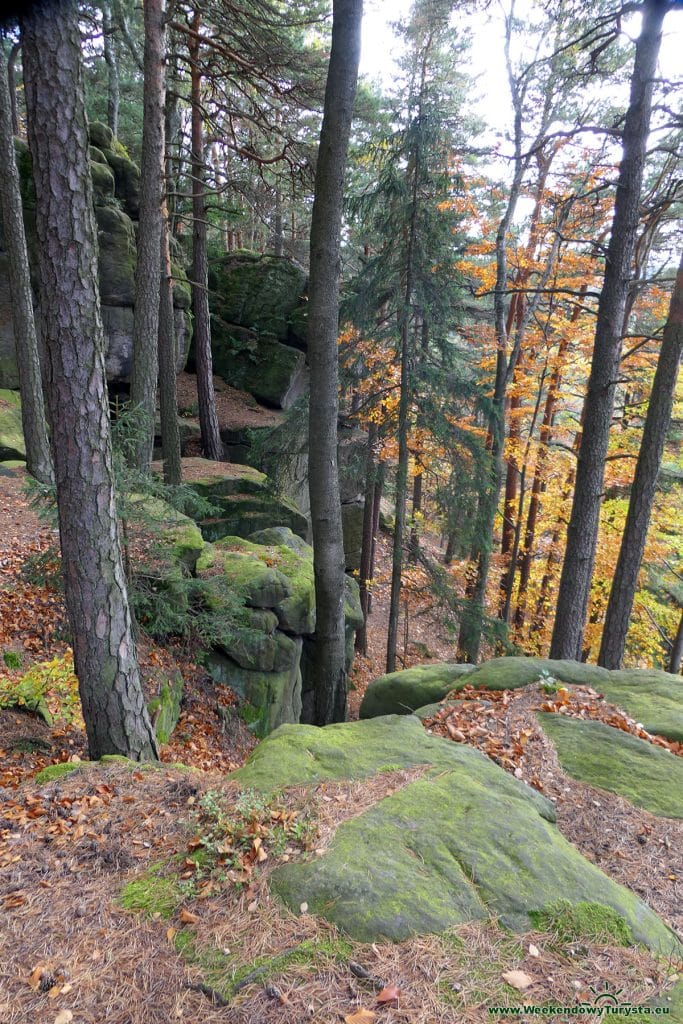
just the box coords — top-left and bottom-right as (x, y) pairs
(232, 716), (677, 952)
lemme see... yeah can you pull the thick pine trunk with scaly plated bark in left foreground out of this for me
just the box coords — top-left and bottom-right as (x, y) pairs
(23, 0), (157, 761)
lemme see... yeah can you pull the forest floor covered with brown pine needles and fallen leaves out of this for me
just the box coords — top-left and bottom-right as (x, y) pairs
(0, 460), (683, 1024)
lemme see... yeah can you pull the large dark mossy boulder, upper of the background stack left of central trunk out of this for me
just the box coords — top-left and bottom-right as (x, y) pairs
(209, 250), (306, 342)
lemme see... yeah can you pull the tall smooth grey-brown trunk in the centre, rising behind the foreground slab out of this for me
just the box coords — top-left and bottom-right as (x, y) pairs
(308, 0), (362, 725)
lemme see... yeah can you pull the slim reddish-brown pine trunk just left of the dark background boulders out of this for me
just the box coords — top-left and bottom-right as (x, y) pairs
(188, 11), (223, 462)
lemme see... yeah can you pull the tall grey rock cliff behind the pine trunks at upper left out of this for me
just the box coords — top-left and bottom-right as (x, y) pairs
(0, 122), (190, 387)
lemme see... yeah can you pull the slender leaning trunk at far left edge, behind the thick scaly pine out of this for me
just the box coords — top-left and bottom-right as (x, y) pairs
(0, 43), (52, 483)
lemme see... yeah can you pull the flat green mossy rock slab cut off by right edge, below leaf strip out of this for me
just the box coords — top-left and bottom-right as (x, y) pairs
(538, 712), (683, 818)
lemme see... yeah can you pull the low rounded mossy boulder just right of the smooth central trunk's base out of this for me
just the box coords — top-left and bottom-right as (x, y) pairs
(359, 663), (474, 718)
